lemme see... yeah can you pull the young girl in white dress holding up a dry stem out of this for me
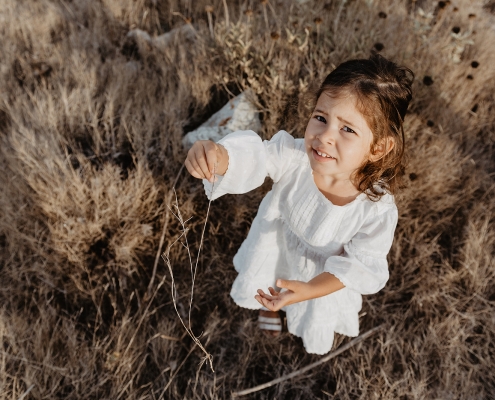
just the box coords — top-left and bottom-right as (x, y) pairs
(185, 55), (414, 354)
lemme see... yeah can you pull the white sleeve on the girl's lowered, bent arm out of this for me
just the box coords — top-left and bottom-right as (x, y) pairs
(324, 206), (398, 294)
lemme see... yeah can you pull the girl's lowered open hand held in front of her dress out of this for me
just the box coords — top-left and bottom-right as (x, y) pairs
(254, 279), (311, 311)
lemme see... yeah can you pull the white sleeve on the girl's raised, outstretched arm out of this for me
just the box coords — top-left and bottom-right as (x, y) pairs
(203, 131), (295, 200)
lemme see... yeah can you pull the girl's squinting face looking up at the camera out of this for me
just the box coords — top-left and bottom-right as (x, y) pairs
(304, 92), (373, 185)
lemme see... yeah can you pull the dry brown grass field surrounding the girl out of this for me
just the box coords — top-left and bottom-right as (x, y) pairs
(0, 0), (495, 400)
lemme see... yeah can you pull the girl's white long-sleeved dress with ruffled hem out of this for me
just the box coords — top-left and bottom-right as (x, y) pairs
(203, 131), (398, 354)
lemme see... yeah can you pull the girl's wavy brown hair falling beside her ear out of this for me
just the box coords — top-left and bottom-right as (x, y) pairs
(316, 54), (414, 201)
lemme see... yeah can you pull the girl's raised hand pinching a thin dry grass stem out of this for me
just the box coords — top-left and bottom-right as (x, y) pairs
(184, 140), (229, 182)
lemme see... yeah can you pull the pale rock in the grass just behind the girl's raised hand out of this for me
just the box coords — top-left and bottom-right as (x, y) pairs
(182, 90), (261, 148)
